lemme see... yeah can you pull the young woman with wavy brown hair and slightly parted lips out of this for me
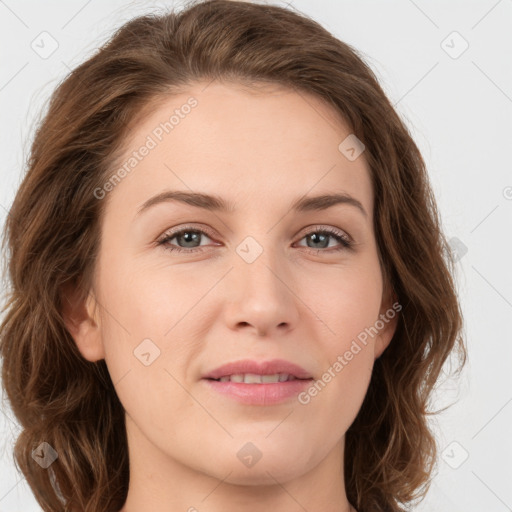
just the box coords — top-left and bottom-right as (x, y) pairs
(0, 0), (465, 512)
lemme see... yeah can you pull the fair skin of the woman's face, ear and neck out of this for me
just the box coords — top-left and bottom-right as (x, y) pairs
(66, 82), (396, 512)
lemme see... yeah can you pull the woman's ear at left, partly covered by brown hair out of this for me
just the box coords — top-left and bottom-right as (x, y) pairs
(61, 283), (105, 362)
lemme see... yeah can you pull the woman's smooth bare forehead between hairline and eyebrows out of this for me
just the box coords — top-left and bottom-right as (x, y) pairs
(106, 82), (373, 218)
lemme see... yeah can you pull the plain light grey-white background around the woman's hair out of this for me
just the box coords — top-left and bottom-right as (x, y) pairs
(0, 0), (512, 512)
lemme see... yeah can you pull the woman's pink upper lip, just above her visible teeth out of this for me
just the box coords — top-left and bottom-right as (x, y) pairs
(203, 359), (312, 379)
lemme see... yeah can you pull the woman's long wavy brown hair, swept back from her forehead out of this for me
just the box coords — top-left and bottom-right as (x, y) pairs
(0, 0), (467, 512)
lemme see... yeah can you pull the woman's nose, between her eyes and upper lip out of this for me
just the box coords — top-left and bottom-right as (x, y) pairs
(223, 246), (301, 337)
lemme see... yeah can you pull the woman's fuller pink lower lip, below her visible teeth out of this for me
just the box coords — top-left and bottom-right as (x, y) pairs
(203, 379), (313, 405)
